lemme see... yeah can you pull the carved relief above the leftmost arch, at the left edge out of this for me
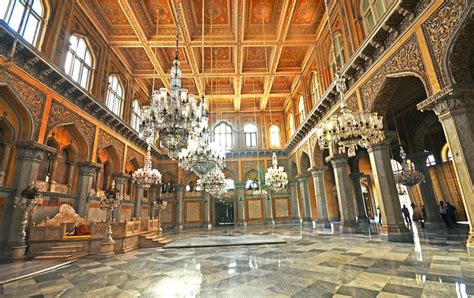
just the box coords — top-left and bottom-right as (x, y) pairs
(0, 69), (46, 136)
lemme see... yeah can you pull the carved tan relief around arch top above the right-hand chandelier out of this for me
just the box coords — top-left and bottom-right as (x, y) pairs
(361, 35), (431, 112)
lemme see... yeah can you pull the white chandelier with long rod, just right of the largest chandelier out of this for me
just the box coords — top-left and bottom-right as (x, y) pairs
(178, 0), (225, 179)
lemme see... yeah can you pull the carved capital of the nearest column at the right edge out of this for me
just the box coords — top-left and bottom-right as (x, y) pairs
(417, 85), (474, 118)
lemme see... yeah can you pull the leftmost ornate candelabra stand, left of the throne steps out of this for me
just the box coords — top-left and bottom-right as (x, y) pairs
(12, 181), (43, 259)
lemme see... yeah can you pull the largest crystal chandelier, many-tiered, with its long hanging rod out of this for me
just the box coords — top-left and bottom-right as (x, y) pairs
(140, 0), (202, 159)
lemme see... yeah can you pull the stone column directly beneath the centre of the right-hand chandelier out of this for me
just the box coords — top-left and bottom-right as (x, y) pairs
(326, 154), (359, 233)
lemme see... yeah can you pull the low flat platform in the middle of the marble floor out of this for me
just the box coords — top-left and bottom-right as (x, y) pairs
(163, 233), (286, 249)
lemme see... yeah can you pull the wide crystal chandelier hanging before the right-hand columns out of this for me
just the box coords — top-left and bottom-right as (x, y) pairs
(316, 74), (385, 157)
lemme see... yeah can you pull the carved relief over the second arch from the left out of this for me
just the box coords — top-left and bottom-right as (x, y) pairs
(47, 100), (96, 156)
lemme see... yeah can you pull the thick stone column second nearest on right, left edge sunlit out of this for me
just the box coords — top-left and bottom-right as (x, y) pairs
(368, 142), (413, 242)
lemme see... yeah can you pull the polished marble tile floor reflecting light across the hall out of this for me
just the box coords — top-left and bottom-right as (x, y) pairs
(0, 226), (474, 297)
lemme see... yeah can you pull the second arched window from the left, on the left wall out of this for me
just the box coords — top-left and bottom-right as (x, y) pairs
(64, 35), (93, 90)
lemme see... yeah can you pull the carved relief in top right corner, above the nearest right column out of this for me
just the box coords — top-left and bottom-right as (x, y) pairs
(422, 0), (472, 86)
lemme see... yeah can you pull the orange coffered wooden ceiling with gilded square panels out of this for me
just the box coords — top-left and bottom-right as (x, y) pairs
(78, 0), (324, 111)
